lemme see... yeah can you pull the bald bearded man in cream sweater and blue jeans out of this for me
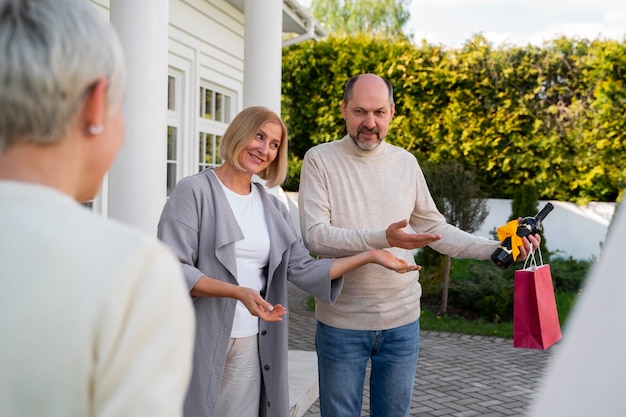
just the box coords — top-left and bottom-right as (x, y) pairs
(299, 74), (539, 417)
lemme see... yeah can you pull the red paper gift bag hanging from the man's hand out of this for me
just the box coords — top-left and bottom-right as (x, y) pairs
(513, 249), (561, 349)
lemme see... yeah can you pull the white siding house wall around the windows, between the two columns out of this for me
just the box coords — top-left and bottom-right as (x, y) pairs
(168, 0), (244, 180)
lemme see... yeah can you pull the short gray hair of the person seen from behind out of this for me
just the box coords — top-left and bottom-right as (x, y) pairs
(0, 0), (125, 152)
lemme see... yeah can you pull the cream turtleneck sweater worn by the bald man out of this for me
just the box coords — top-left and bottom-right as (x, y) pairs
(299, 136), (499, 330)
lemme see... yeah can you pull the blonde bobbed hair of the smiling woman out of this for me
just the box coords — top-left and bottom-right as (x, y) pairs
(219, 106), (288, 187)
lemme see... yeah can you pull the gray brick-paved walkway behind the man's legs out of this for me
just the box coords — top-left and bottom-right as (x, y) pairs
(289, 285), (558, 417)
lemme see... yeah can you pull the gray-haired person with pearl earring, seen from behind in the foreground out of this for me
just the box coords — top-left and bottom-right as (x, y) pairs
(0, 0), (194, 417)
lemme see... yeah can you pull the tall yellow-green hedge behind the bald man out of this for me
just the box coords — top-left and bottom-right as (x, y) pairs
(282, 35), (626, 203)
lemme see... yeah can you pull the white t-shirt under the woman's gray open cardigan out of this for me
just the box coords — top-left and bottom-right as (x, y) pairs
(220, 176), (270, 338)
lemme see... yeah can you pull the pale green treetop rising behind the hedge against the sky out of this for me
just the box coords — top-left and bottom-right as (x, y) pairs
(310, 0), (411, 39)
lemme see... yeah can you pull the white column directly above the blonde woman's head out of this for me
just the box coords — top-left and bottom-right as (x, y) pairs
(243, 0), (283, 115)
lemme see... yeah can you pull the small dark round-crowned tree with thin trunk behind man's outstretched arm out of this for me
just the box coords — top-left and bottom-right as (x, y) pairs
(424, 160), (489, 313)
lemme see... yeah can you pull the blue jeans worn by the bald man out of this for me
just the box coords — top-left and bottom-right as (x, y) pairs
(315, 320), (420, 417)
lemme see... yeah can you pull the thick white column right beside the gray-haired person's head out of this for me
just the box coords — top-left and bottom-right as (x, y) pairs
(108, 0), (169, 235)
